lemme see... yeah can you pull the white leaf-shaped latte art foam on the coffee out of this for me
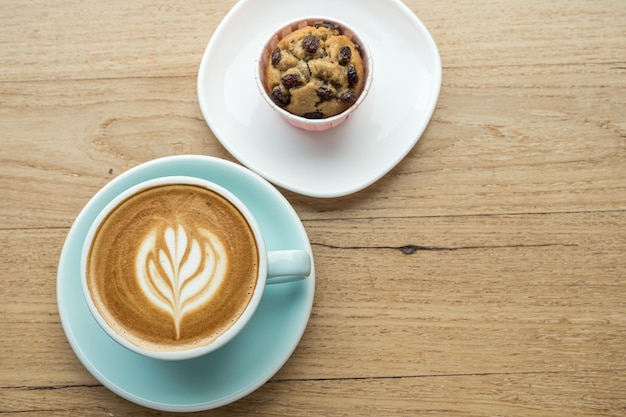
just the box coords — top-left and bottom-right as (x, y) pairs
(135, 225), (227, 340)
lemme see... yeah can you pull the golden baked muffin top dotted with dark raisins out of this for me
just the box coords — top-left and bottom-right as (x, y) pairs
(266, 22), (365, 119)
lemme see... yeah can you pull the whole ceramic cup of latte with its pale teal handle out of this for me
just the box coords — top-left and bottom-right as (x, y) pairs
(80, 176), (311, 360)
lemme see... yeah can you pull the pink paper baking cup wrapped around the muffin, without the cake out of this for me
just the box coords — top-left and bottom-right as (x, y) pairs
(255, 16), (373, 132)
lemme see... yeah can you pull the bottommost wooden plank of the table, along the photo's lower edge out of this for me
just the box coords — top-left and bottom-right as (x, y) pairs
(4, 372), (626, 417)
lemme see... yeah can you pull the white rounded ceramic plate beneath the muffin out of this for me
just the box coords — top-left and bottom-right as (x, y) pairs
(198, 0), (441, 197)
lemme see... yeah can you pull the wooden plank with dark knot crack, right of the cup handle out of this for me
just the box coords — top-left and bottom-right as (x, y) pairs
(0, 212), (626, 386)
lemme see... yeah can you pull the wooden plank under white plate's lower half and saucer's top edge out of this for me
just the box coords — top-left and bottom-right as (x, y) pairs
(0, 66), (626, 227)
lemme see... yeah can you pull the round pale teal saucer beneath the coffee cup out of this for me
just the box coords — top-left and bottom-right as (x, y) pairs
(57, 155), (315, 412)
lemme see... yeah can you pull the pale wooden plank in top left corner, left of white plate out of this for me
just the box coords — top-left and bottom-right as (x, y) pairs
(0, 0), (236, 81)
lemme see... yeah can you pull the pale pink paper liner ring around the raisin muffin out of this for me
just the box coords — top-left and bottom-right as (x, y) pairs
(254, 15), (374, 130)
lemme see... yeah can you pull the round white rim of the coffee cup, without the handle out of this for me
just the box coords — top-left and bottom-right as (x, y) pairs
(80, 175), (267, 360)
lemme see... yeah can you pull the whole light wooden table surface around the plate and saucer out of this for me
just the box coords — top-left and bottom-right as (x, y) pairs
(0, 0), (626, 417)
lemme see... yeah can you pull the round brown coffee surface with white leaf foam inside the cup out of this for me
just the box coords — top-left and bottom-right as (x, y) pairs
(86, 184), (259, 351)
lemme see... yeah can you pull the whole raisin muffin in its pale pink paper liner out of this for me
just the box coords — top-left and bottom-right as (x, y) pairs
(257, 18), (371, 130)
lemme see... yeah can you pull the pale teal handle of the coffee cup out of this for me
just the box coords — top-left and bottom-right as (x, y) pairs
(266, 249), (311, 284)
